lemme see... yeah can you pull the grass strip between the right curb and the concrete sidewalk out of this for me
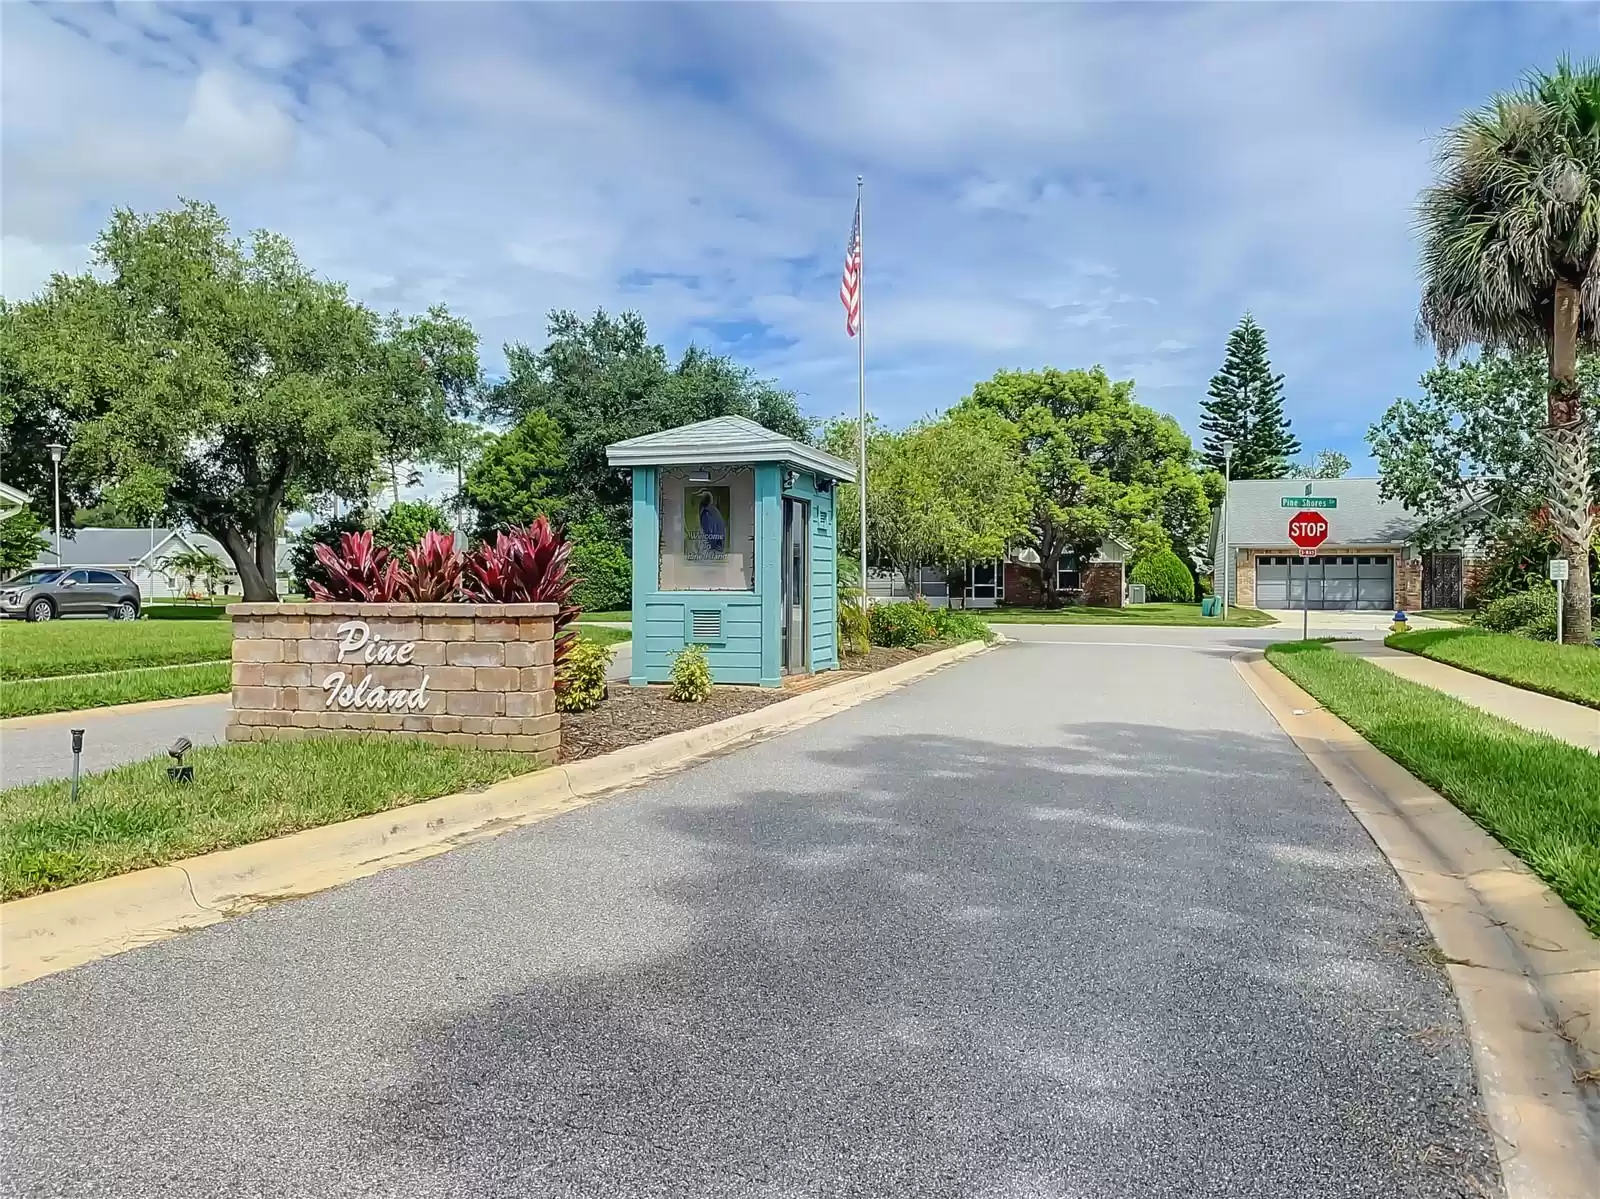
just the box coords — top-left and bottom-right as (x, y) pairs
(1267, 634), (1600, 933)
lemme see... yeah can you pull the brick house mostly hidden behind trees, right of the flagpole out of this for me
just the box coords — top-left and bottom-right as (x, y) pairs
(867, 538), (1133, 608)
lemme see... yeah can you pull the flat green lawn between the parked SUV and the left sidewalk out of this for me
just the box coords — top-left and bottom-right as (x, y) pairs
(0, 620), (234, 679)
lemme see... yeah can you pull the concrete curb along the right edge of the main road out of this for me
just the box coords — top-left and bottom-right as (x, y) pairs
(1234, 652), (1600, 1199)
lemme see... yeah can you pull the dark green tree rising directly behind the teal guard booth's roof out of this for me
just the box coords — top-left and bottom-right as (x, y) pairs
(485, 312), (810, 530)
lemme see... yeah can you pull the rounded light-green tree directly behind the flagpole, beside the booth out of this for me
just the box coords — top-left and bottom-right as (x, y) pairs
(824, 408), (1032, 589)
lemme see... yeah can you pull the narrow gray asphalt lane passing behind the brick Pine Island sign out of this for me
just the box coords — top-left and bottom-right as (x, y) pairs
(0, 642), (632, 788)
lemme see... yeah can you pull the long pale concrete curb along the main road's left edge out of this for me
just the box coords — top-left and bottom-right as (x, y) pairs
(0, 642), (987, 989)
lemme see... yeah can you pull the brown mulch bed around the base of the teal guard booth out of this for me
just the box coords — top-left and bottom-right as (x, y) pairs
(562, 645), (946, 762)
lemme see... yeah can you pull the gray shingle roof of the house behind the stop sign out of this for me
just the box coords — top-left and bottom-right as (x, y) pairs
(1213, 479), (1422, 551)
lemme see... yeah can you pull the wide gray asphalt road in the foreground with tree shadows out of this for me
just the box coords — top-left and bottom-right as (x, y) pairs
(0, 628), (1498, 1199)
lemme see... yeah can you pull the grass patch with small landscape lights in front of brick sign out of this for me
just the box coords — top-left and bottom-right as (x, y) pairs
(0, 736), (533, 900)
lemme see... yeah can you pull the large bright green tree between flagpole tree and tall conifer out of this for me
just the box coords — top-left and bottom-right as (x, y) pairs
(960, 367), (1221, 605)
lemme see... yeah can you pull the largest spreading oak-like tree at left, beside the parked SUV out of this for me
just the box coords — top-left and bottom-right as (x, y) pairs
(9, 203), (466, 600)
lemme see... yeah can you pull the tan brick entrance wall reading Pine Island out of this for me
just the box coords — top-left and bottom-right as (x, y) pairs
(227, 602), (562, 762)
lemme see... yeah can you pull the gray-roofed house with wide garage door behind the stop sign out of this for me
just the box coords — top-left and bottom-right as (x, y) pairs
(1211, 479), (1477, 612)
